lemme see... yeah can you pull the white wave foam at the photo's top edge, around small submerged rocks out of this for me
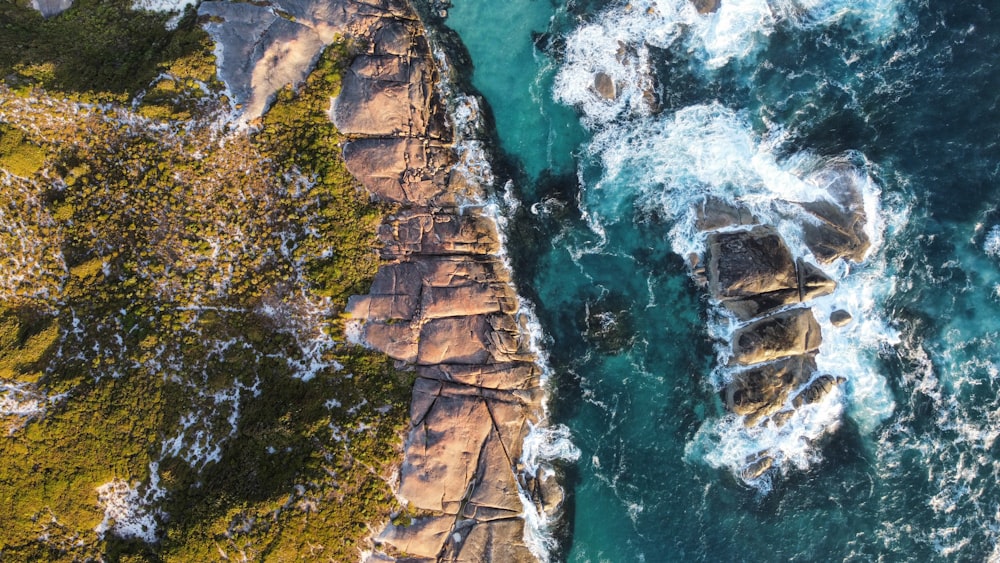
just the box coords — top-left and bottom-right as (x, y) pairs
(554, 0), (900, 128)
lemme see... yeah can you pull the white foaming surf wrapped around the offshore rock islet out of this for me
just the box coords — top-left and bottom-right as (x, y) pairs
(582, 104), (908, 490)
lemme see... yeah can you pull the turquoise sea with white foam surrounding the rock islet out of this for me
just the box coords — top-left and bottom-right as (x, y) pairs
(447, 0), (1000, 561)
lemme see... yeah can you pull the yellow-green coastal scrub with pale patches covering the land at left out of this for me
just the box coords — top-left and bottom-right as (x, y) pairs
(0, 7), (412, 561)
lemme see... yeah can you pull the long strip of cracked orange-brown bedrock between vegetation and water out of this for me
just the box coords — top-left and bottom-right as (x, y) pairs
(331, 1), (562, 562)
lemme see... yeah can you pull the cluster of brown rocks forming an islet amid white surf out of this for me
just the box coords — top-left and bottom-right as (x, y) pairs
(691, 173), (869, 481)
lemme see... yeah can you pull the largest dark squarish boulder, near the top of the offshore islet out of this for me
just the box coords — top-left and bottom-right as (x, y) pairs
(708, 226), (798, 300)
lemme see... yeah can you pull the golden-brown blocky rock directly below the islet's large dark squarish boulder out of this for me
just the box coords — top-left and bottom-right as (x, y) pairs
(733, 309), (823, 365)
